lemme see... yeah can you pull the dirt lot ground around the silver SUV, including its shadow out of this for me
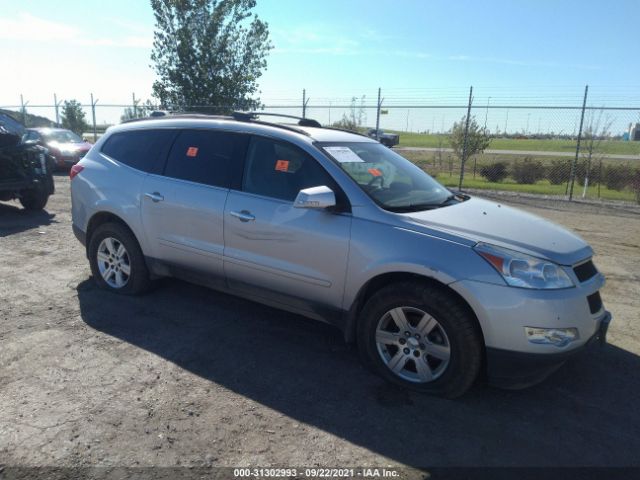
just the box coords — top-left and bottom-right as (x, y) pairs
(0, 176), (640, 466)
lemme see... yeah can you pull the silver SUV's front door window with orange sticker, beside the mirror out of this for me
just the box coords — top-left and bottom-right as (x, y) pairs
(242, 137), (334, 202)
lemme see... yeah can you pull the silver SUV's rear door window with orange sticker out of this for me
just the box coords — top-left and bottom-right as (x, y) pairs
(164, 130), (240, 188)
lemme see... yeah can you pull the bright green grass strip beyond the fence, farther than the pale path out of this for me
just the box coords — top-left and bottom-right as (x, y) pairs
(394, 132), (640, 155)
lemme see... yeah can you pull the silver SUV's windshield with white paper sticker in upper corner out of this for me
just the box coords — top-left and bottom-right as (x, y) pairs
(321, 142), (452, 212)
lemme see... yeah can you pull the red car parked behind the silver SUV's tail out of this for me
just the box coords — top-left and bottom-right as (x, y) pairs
(27, 128), (92, 170)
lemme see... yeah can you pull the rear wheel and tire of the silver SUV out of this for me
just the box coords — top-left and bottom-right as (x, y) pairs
(87, 223), (151, 295)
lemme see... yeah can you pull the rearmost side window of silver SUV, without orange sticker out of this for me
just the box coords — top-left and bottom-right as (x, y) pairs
(101, 130), (175, 172)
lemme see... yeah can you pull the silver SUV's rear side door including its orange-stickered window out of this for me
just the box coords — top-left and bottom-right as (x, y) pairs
(142, 129), (246, 285)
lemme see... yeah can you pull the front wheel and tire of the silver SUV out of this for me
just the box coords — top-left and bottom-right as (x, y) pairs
(357, 282), (483, 398)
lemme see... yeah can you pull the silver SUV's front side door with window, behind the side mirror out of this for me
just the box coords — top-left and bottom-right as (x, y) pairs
(224, 136), (351, 317)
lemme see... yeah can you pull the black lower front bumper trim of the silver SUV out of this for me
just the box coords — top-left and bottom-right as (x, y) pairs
(486, 312), (611, 389)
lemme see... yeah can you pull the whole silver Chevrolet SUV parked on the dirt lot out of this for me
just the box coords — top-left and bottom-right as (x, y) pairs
(71, 115), (611, 397)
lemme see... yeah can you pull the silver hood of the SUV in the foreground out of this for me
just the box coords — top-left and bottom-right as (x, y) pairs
(402, 197), (593, 265)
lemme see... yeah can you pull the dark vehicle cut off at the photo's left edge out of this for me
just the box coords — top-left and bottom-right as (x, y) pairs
(0, 113), (54, 210)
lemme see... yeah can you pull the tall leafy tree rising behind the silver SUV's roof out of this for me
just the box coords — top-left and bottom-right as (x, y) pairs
(151, 0), (272, 113)
